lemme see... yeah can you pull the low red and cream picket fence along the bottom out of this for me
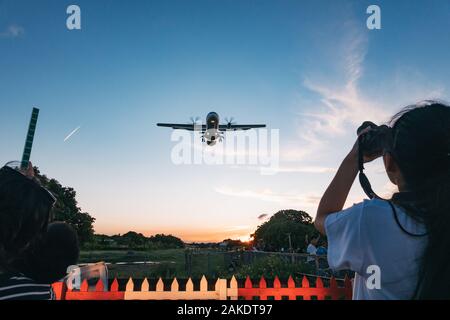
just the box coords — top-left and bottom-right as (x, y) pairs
(53, 276), (352, 300)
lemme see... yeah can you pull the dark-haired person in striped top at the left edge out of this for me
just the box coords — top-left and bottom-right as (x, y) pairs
(0, 163), (55, 300)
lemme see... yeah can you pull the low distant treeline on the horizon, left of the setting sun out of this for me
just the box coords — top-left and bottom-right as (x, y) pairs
(84, 231), (184, 250)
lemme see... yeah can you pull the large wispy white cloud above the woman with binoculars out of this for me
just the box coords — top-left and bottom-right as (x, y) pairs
(292, 21), (445, 165)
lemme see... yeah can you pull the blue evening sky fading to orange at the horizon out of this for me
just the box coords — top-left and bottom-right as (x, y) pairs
(0, 0), (450, 241)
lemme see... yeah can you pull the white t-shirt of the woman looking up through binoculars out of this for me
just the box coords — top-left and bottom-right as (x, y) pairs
(325, 199), (426, 300)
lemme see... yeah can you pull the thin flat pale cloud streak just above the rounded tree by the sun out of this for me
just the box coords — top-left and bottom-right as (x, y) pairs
(214, 186), (321, 207)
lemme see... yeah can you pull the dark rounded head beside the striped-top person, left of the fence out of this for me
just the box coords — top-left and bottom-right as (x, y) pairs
(15, 222), (80, 284)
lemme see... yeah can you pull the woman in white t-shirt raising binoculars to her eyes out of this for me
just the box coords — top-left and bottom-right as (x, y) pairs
(314, 101), (450, 299)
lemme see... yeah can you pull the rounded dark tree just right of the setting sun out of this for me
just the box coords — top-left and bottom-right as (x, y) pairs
(252, 209), (316, 252)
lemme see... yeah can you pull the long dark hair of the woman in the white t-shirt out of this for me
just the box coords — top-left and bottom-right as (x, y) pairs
(391, 101), (450, 299)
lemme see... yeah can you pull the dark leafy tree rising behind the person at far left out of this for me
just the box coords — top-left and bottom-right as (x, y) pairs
(34, 167), (95, 245)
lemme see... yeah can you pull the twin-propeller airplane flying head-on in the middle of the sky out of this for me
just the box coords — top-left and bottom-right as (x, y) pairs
(156, 112), (266, 146)
